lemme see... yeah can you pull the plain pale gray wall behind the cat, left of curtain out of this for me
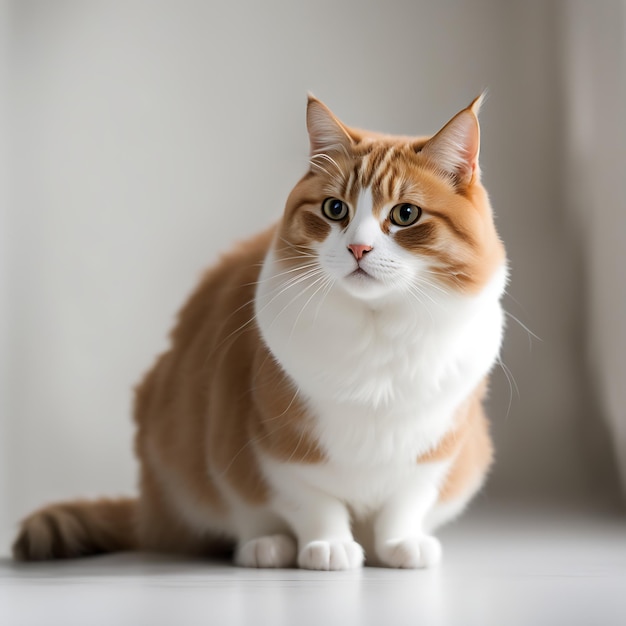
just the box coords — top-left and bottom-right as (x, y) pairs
(0, 0), (606, 552)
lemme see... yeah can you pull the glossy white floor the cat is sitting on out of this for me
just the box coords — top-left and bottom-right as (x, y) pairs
(0, 503), (626, 626)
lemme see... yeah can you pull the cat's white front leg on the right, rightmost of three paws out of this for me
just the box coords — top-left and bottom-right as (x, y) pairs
(374, 481), (441, 569)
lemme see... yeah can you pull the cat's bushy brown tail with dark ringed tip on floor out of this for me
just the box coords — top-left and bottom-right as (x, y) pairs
(13, 498), (137, 561)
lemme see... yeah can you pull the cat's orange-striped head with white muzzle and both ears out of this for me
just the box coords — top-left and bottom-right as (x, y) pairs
(274, 96), (505, 301)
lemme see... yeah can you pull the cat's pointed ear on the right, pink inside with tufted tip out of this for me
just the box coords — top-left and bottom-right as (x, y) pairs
(420, 94), (484, 187)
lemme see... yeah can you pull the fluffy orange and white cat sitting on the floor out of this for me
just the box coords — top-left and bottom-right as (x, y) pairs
(13, 96), (507, 570)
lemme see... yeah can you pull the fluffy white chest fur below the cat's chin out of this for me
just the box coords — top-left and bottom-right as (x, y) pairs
(256, 253), (505, 508)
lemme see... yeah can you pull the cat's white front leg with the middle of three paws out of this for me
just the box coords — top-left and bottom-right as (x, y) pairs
(275, 488), (364, 570)
